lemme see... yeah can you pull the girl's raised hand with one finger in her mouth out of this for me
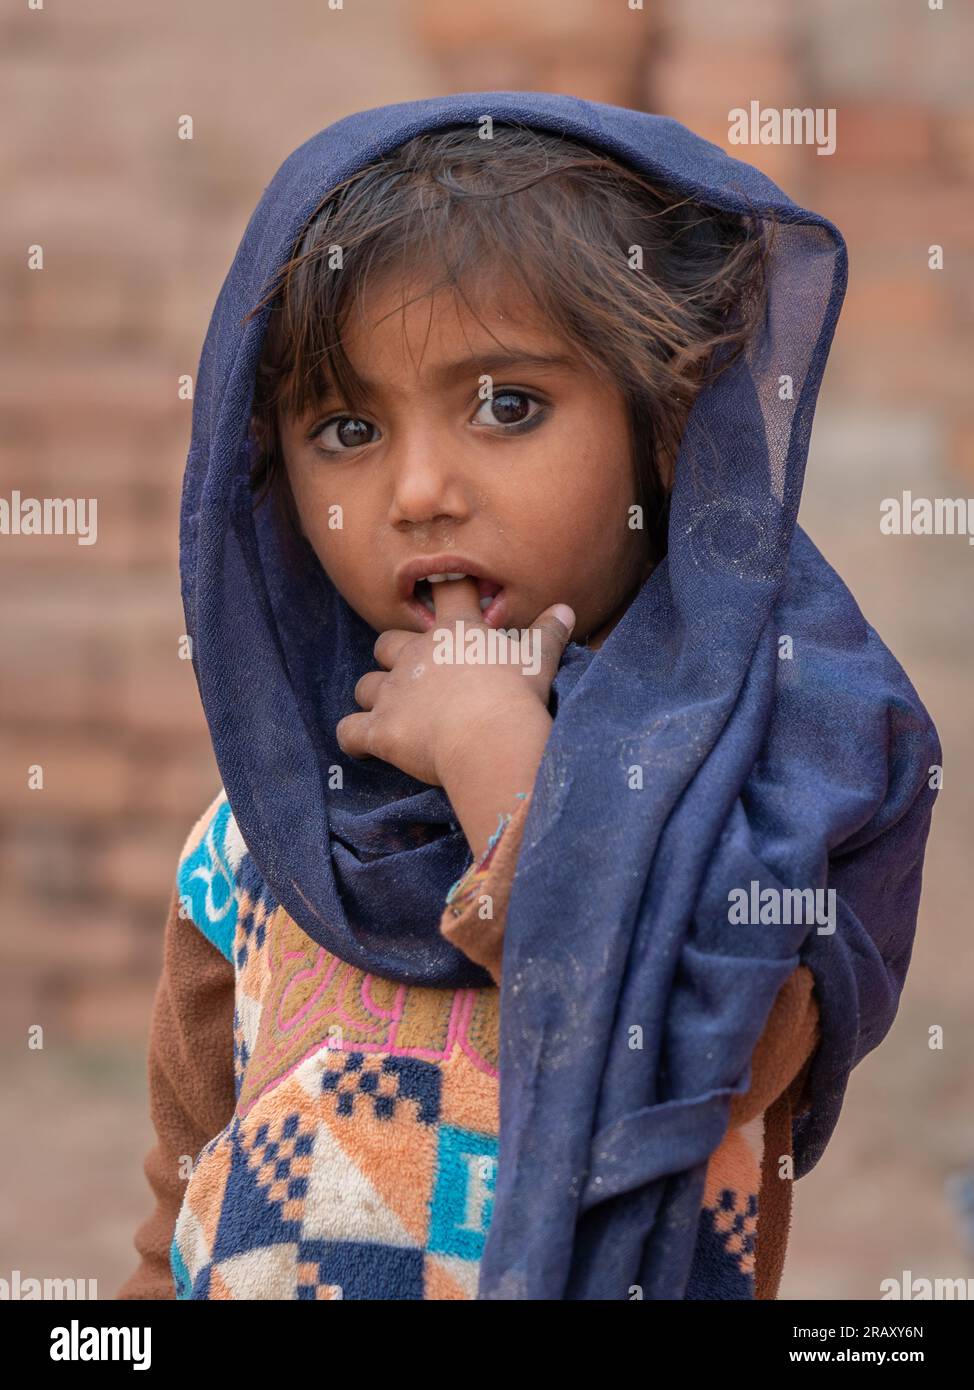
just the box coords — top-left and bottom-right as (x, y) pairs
(335, 578), (571, 787)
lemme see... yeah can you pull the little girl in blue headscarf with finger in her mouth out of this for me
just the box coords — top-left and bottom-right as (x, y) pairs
(119, 93), (939, 1300)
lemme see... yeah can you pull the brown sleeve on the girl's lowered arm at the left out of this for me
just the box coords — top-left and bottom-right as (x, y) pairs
(115, 887), (236, 1300)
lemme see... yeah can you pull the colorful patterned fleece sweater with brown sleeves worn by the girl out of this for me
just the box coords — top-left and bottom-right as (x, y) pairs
(117, 791), (818, 1300)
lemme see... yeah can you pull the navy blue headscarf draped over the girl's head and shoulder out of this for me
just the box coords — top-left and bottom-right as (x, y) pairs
(181, 92), (941, 1298)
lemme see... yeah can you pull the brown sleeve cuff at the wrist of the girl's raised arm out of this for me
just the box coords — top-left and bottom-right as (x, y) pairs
(439, 792), (531, 984)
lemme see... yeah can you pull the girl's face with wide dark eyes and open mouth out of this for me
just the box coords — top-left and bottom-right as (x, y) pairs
(278, 271), (652, 646)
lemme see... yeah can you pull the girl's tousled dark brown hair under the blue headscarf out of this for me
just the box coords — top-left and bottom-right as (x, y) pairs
(245, 125), (773, 562)
